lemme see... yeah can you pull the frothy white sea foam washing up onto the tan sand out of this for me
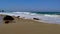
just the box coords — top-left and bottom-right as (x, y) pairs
(0, 12), (60, 24)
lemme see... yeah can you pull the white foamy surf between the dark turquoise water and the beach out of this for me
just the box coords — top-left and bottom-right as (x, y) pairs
(0, 12), (60, 23)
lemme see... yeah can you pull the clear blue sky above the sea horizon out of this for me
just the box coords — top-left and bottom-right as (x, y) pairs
(0, 0), (60, 11)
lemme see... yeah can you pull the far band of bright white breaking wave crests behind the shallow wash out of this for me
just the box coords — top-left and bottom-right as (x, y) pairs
(0, 12), (60, 17)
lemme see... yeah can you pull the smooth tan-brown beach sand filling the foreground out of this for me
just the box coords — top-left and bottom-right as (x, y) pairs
(0, 14), (60, 34)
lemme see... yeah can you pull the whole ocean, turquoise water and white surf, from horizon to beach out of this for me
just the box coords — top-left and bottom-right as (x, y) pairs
(0, 12), (60, 24)
